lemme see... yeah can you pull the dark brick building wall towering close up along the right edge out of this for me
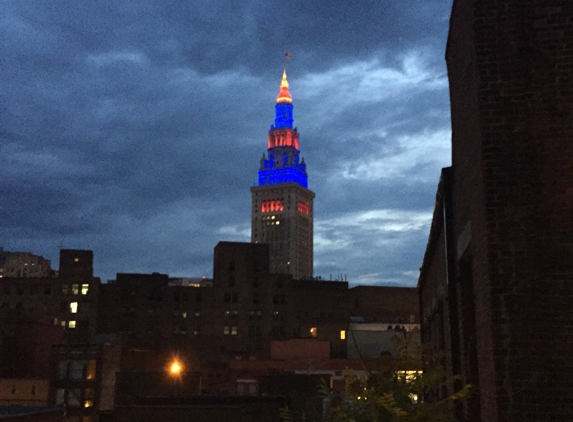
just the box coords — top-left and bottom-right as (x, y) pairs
(419, 0), (573, 422)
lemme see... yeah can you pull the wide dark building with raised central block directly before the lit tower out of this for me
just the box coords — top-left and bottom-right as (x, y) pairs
(98, 242), (418, 366)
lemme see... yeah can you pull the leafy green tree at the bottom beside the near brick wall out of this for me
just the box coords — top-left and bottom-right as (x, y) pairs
(281, 334), (470, 422)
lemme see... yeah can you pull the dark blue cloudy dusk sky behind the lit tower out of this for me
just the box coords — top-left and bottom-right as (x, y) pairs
(0, 0), (451, 286)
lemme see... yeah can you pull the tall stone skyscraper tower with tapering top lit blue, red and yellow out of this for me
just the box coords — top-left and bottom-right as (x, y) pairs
(251, 72), (314, 279)
